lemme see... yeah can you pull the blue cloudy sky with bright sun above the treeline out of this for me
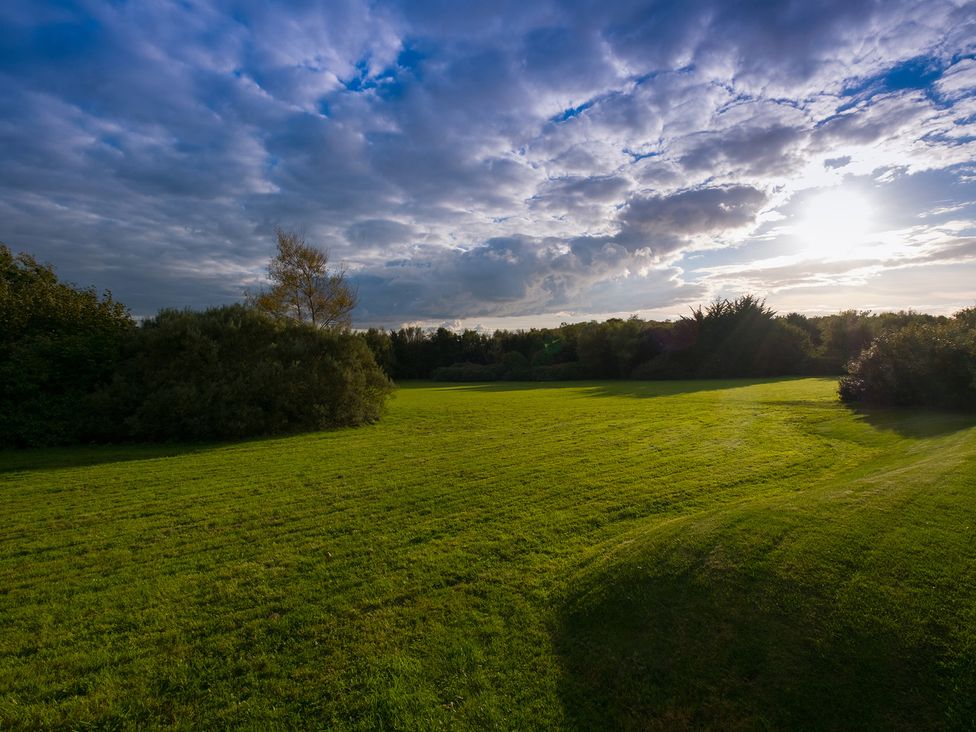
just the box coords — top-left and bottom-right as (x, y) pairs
(0, 0), (976, 329)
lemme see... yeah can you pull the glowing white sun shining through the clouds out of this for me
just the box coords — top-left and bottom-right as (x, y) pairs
(794, 188), (874, 259)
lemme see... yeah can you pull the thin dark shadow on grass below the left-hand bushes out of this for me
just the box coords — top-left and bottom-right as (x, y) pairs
(0, 443), (214, 475)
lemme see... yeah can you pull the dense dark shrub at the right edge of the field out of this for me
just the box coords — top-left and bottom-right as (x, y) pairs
(840, 309), (976, 410)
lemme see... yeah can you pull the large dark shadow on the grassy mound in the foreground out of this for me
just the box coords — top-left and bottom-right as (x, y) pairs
(556, 565), (976, 730)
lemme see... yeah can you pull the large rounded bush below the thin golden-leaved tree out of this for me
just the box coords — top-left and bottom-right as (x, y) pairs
(99, 305), (392, 440)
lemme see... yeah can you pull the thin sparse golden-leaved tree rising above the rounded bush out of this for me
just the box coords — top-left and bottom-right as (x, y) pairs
(247, 229), (357, 329)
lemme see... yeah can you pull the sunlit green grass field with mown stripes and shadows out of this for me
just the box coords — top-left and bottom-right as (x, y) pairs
(0, 379), (976, 729)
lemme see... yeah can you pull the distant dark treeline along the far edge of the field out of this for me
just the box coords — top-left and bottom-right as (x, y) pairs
(362, 295), (947, 381)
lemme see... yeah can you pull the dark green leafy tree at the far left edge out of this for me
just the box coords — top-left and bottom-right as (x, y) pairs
(0, 244), (134, 446)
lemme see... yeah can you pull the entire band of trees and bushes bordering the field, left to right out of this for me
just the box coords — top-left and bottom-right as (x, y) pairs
(0, 239), (976, 446)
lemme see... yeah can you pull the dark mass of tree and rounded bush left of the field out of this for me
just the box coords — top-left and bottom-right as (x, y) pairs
(0, 245), (392, 447)
